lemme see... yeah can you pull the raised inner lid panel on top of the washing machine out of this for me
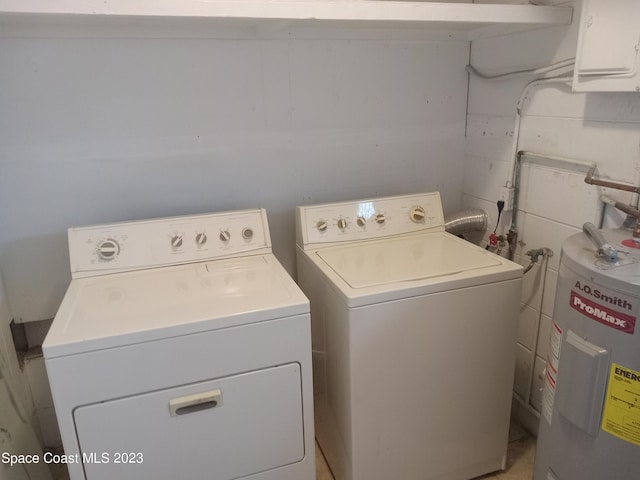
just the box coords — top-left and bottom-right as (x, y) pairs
(318, 233), (501, 288)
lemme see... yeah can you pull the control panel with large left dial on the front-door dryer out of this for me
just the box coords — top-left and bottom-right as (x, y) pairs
(68, 209), (271, 278)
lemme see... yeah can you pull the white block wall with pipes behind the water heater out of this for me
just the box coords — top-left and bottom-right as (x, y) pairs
(464, 2), (640, 430)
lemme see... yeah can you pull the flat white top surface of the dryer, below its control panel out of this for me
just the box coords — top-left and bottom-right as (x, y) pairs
(42, 254), (309, 358)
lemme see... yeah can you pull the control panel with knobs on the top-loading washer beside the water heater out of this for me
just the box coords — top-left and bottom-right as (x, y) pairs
(296, 192), (444, 245)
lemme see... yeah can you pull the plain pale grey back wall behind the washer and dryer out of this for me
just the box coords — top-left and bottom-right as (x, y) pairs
(0, 30), (469, 321)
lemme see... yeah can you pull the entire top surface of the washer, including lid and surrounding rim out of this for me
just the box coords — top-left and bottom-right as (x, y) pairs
(310, 232), (523, 308)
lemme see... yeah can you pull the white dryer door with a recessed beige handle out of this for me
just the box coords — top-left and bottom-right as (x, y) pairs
(74, 363), (305, 480)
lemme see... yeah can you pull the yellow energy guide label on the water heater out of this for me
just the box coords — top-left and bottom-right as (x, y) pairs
(602, 363), (640, 446)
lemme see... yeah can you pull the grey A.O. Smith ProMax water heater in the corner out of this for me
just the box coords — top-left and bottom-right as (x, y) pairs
(533, 224), (640, 480)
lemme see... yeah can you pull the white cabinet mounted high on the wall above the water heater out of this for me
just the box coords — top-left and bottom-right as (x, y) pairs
(573, 0), (640, 92)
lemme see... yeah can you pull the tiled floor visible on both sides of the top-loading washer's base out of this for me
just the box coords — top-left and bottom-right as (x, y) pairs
(316, 425), (536, 480)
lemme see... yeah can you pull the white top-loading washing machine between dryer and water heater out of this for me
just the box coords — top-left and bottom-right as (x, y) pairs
(297, 193), (522, 480)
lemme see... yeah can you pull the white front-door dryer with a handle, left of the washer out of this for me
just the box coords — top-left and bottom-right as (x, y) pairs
(42, 210), (315, 480)
